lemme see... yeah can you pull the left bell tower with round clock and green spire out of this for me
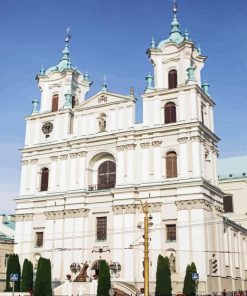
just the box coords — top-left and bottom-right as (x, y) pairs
(25, 31), (92, 146)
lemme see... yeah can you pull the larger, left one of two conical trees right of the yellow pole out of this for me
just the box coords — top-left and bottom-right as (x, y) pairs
(155, 255), (172, 296)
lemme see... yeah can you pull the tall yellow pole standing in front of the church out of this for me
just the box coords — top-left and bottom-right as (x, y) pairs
(138, 199), (149, 296)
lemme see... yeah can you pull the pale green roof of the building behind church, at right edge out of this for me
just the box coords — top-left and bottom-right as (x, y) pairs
(218, 155), (247, 179)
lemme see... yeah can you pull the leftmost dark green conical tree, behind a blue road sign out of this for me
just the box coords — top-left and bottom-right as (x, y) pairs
(5, 254), (21, 292)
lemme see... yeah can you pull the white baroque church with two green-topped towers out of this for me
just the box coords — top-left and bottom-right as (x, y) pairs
(15, 3), (247, 293)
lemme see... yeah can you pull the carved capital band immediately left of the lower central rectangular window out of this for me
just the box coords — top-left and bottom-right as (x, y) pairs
(44, 209), (89, 220)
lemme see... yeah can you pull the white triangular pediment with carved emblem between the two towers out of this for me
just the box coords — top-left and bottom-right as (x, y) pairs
(78, 91), (135, 109)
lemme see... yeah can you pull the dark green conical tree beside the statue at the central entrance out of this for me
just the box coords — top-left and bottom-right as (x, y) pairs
(97, 260), (111, 296)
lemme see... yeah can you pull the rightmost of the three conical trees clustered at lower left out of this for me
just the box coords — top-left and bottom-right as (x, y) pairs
(34, 257), (52, 296)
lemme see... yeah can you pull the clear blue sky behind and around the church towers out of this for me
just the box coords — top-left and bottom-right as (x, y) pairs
(0, 0), (247, 213)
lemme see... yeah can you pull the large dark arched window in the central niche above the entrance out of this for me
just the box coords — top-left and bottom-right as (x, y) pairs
(98, 161), (116, 190)
